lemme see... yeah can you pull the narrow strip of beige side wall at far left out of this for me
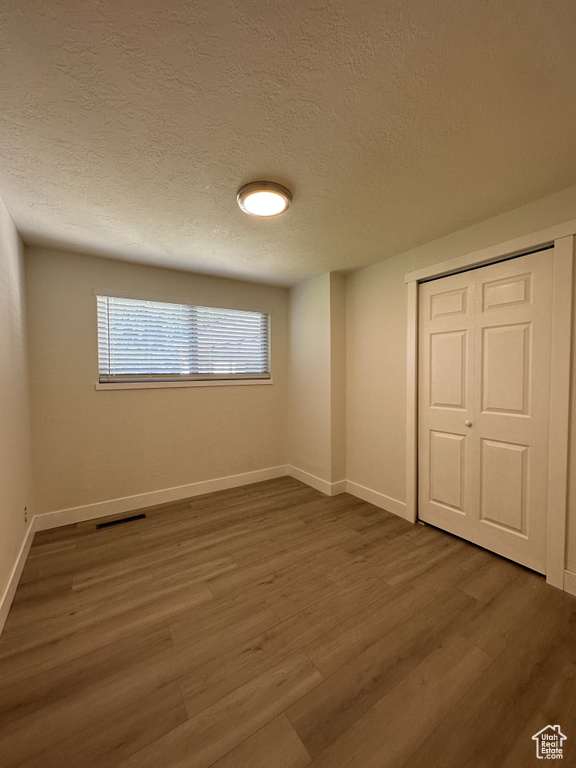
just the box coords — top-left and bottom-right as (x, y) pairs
(0, 196), (34, 597)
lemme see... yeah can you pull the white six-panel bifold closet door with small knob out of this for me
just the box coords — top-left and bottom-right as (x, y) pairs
(418, 251), (553, 573)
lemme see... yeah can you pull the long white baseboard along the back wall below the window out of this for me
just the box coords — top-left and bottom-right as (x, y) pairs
(35, 465), (286, 531)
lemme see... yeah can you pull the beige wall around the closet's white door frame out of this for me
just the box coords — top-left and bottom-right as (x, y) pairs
(346, 187), (576, 571)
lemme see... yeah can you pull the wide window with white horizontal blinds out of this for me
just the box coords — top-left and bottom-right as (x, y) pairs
(97, 296), (270, 384)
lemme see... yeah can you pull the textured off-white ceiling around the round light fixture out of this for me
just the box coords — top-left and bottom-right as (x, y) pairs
(0, 0), (576, 285)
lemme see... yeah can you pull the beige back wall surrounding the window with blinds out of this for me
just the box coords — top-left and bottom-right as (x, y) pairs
(26, 248), (288, 513)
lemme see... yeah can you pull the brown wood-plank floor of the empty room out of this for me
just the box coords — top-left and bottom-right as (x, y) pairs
(0, 478), (576, 768)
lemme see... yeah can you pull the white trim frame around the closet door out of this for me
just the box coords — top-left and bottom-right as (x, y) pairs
(405, 220), (576, 589)
